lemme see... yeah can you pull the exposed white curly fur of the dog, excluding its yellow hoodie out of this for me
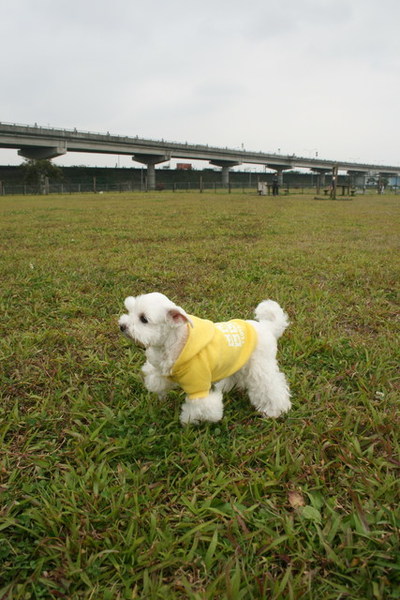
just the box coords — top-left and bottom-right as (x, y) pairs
(119, 292), (291, 425)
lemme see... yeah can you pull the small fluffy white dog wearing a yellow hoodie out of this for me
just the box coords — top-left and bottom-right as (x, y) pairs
(119, 292), (291, 424)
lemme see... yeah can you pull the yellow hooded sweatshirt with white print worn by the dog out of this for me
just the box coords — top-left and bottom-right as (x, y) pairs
(170, 315), (257, 400)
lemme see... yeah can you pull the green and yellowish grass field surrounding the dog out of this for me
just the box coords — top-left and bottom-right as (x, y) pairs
(0, 193), (400, 600)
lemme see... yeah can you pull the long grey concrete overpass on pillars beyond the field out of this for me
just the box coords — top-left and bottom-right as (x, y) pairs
(0, 123), (400, 189)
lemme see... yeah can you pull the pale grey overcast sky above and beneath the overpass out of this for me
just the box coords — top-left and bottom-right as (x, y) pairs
(0, 0), (400, 166)
